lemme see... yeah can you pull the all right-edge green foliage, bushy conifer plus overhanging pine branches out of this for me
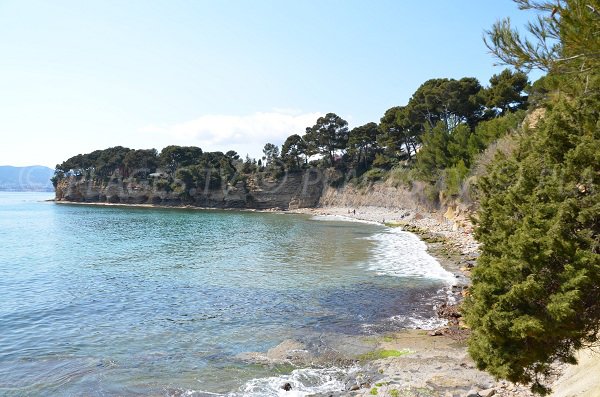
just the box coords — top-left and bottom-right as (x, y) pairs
(464, 1), (600, 394)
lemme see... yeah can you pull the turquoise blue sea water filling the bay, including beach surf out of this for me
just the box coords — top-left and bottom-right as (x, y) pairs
(0, 193), (452, 396)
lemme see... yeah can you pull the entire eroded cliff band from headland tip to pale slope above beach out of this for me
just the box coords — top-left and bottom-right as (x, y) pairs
(56, 169), (472, 228)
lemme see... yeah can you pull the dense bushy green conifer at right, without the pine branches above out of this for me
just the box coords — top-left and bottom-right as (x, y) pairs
(466, 91), (600, 390)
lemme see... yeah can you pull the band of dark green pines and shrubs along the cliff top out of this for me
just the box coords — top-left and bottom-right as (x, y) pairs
(53, 65), (535, 202)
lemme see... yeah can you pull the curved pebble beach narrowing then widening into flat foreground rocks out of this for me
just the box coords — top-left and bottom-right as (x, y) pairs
(294, 206), (556, 397)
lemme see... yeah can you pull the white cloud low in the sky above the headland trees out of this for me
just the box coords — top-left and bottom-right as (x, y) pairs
(140, 109), (323, 157)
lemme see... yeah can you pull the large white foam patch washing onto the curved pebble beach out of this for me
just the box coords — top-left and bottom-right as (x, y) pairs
(365, 228), (456, 285)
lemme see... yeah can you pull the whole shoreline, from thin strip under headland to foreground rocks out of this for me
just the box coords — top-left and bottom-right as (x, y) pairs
(54, 201), (496, 397)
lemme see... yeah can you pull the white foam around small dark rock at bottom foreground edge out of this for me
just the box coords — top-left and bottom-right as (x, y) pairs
(228, 367), (359, 397)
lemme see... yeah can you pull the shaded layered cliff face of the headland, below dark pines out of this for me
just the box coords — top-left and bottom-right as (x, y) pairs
(56, 170), (326, 210)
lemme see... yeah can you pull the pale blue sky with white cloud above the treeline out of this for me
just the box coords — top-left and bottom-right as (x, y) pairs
(0, 0), (544, 167)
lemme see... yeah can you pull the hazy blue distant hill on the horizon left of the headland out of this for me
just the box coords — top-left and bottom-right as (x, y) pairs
(0, 165), (54, 192)
